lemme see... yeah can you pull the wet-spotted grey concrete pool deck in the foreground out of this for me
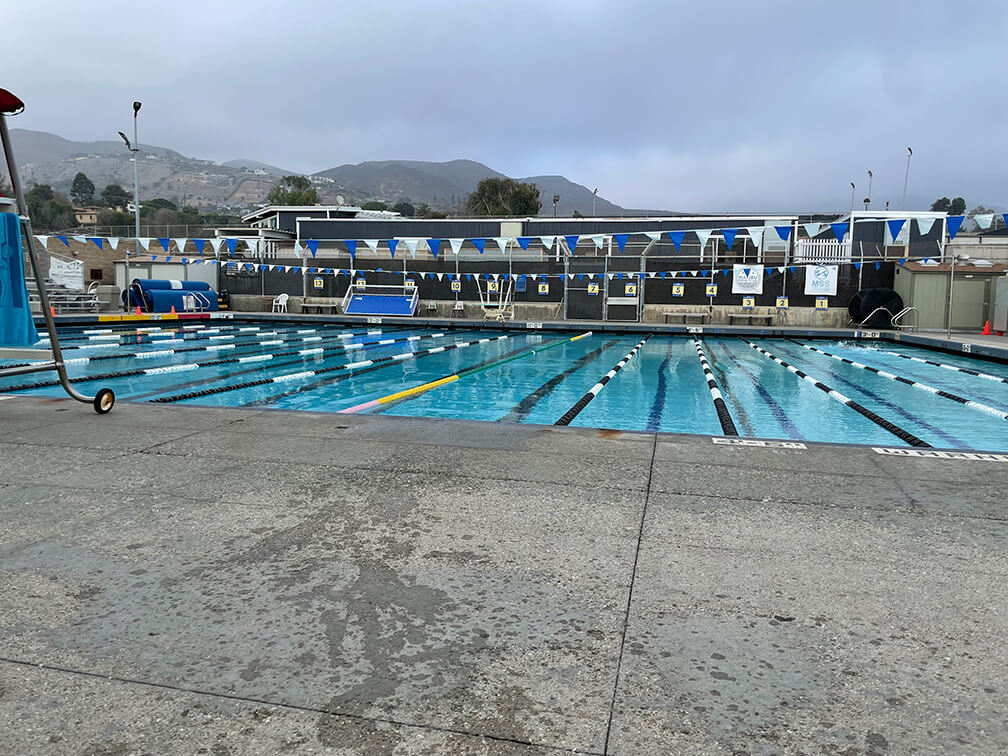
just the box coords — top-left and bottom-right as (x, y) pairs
(0, 397), (1008, 754)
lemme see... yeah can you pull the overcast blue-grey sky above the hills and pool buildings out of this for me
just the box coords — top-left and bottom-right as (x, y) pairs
(7, 0), (1008, 212)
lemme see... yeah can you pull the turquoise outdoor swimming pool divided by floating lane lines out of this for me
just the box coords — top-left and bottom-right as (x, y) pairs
(0, 321), (1008, 451)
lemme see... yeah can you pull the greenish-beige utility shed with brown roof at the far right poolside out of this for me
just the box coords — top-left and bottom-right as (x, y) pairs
(893, 260), (1008, 331)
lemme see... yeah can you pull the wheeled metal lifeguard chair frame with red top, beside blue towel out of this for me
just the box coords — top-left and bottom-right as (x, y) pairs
(0, 89), (116, 414)
